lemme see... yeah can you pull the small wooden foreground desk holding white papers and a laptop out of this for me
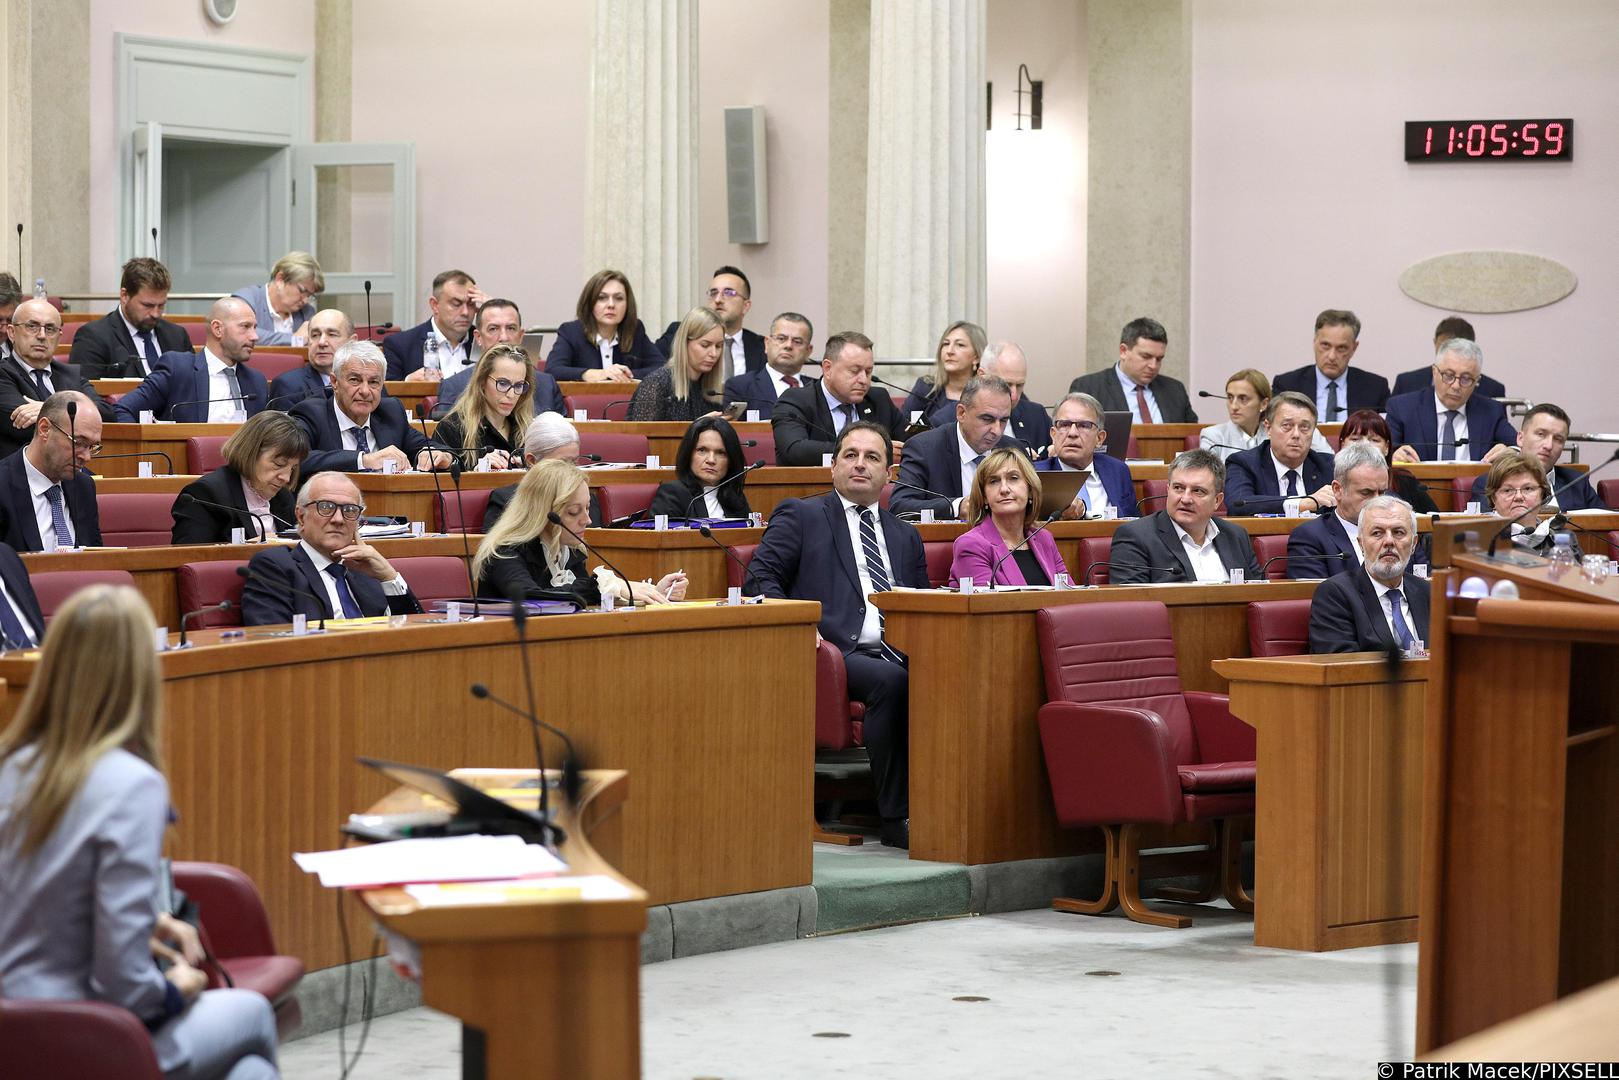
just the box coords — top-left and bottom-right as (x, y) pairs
(359, 769), (646, 1080)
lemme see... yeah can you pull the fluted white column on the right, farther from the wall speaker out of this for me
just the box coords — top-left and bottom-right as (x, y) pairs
(861, 0), (988, 358)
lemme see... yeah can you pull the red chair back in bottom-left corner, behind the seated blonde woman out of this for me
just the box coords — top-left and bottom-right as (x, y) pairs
(0, 997), (164, 1080)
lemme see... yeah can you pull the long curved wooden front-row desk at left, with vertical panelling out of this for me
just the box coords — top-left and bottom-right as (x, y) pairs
(0, 601), (819, 968)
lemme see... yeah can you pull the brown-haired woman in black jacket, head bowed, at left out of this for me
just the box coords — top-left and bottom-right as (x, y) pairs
(170, 411), (309, 544)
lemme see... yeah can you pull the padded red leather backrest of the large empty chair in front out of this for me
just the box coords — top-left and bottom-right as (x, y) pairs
(1035, 601), (1198, 764)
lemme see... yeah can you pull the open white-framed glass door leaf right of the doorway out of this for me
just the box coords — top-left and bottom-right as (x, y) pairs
(291, 142), (418, 325)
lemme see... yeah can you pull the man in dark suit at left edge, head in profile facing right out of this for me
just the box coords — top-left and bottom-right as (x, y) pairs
(0, 390), (102, 551)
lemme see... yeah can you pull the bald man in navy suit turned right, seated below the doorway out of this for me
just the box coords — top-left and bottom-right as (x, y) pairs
(115, 296), (270, 424)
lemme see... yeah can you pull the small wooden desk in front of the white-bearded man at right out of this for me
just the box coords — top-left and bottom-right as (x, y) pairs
(1214, 653), (1428, 952)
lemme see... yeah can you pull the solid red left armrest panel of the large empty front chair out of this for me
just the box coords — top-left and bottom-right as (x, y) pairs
(1039, 701), (1185, 826)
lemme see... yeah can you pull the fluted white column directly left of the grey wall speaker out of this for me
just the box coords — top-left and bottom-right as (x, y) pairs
(580, 0), (698, 338)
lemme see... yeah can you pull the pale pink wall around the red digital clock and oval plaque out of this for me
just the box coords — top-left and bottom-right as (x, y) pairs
(1192, 0), (1619, 431)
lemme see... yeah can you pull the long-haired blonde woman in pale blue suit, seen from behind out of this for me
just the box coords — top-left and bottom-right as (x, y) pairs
(0, 585), (277, 1080)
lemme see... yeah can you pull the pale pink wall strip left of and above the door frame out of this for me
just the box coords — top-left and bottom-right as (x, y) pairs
(89, 0), (316, 291)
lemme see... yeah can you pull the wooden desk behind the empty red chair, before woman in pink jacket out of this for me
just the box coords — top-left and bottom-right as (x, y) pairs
(876, 581), (1316, 863)
